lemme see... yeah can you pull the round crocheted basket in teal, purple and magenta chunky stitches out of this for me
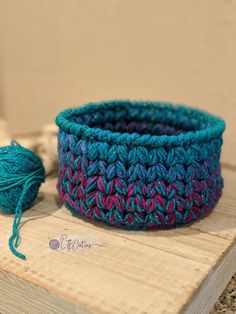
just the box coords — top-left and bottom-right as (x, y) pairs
(56, 100), (225, 229)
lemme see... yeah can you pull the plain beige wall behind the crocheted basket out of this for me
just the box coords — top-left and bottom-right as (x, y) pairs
(0, 0), (236, 161)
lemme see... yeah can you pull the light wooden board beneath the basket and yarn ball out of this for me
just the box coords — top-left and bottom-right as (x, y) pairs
(0, 169), (236, 314)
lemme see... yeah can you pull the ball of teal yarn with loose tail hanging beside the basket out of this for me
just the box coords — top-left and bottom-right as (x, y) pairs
(0, 141), (45, 259)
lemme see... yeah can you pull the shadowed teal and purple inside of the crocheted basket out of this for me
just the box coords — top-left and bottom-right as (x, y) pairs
(69, 104), (209, 135)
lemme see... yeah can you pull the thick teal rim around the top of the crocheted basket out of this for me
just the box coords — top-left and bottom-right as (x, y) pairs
(56, 99), (225, 147)
